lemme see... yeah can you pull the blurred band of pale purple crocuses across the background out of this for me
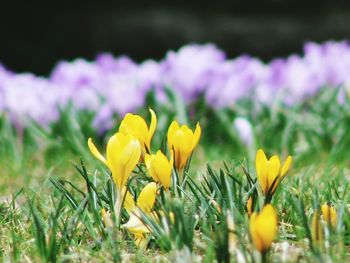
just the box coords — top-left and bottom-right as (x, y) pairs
(0, 41), (350, 129)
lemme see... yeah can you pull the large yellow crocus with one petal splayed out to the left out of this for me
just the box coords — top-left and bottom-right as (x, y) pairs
(88, 132), (141, 190)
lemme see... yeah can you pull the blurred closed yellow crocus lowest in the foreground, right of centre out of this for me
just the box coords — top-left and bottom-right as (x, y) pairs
(249, 204), (277, 254)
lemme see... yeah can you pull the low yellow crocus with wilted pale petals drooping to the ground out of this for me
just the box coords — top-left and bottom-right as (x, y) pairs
(123, 182), (157, 246)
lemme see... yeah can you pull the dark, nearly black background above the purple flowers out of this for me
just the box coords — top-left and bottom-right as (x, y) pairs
(0, 0), (350, 75)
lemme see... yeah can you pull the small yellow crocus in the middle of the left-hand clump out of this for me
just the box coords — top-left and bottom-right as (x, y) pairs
(145, 151), (174, 190)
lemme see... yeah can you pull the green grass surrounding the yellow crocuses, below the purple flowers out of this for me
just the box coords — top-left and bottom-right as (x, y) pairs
(0, 90), (350, 262)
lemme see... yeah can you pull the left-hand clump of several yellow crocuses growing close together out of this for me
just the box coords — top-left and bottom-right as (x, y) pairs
(88, 109), (201, 246)
